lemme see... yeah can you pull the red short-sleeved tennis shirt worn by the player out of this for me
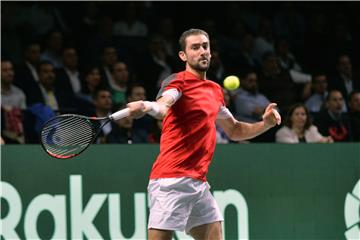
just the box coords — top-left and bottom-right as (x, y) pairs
(150, 71), (224, 181)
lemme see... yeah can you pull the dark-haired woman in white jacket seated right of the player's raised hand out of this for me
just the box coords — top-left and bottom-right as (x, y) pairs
(275, 103), (333, 143)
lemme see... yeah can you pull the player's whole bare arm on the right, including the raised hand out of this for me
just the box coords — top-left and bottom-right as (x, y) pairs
(216, 103), (281, 141)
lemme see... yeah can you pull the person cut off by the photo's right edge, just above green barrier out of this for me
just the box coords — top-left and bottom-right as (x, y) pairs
(349, 91), (360, 141)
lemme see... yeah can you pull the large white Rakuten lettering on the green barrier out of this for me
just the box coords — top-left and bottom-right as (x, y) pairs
(0, 175), (249, 239)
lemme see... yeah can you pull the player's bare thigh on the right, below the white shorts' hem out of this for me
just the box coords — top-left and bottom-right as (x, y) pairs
(190, 222), (223, 240)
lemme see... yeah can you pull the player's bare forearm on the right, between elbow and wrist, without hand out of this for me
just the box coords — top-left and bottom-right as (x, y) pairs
(229, 121), (271, 141)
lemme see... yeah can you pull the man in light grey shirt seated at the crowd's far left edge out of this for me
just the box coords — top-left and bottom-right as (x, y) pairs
(1, 59), (26, 143)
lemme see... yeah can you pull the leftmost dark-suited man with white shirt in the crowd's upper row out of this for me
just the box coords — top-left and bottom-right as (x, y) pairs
(14, 42), (41, 89)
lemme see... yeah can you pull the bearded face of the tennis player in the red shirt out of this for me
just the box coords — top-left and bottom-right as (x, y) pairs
(181, 34), (211, 72)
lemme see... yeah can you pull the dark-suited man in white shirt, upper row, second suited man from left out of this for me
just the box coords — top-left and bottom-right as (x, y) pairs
(55, 47), (81, 95)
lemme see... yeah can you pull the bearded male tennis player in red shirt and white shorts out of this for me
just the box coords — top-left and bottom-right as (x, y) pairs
(128, 29), (281, 240)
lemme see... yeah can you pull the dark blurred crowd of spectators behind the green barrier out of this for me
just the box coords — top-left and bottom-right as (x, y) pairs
(1, 2), (360, 144)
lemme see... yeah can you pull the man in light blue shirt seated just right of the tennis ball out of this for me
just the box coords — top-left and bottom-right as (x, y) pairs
(233, 70), (270, 123)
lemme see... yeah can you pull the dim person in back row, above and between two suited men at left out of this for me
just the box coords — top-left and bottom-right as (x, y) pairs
(40, 30), (63, 68)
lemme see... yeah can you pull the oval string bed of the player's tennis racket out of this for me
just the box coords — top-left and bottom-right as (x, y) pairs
(42, 116), (95, 157)
